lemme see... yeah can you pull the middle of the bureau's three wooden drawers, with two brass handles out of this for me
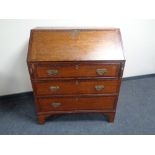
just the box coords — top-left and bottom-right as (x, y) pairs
(34, 79), (120, 95)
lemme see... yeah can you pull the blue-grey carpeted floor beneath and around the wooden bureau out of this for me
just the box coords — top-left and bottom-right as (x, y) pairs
(0, 77), (155, 135)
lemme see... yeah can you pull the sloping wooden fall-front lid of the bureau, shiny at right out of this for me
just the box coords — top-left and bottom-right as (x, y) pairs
(28, 29), (124, 61)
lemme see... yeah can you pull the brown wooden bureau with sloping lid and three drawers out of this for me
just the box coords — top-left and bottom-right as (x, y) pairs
(27, 28), (125, 124)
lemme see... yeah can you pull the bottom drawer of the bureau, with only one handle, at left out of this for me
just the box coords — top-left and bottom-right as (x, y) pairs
(38, 96), (116, 112)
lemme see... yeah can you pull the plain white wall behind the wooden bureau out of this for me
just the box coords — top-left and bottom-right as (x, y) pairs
(0, 20), (155, 96)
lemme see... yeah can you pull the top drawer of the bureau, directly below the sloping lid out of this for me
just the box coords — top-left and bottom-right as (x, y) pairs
(35, 63), (120, 78)
